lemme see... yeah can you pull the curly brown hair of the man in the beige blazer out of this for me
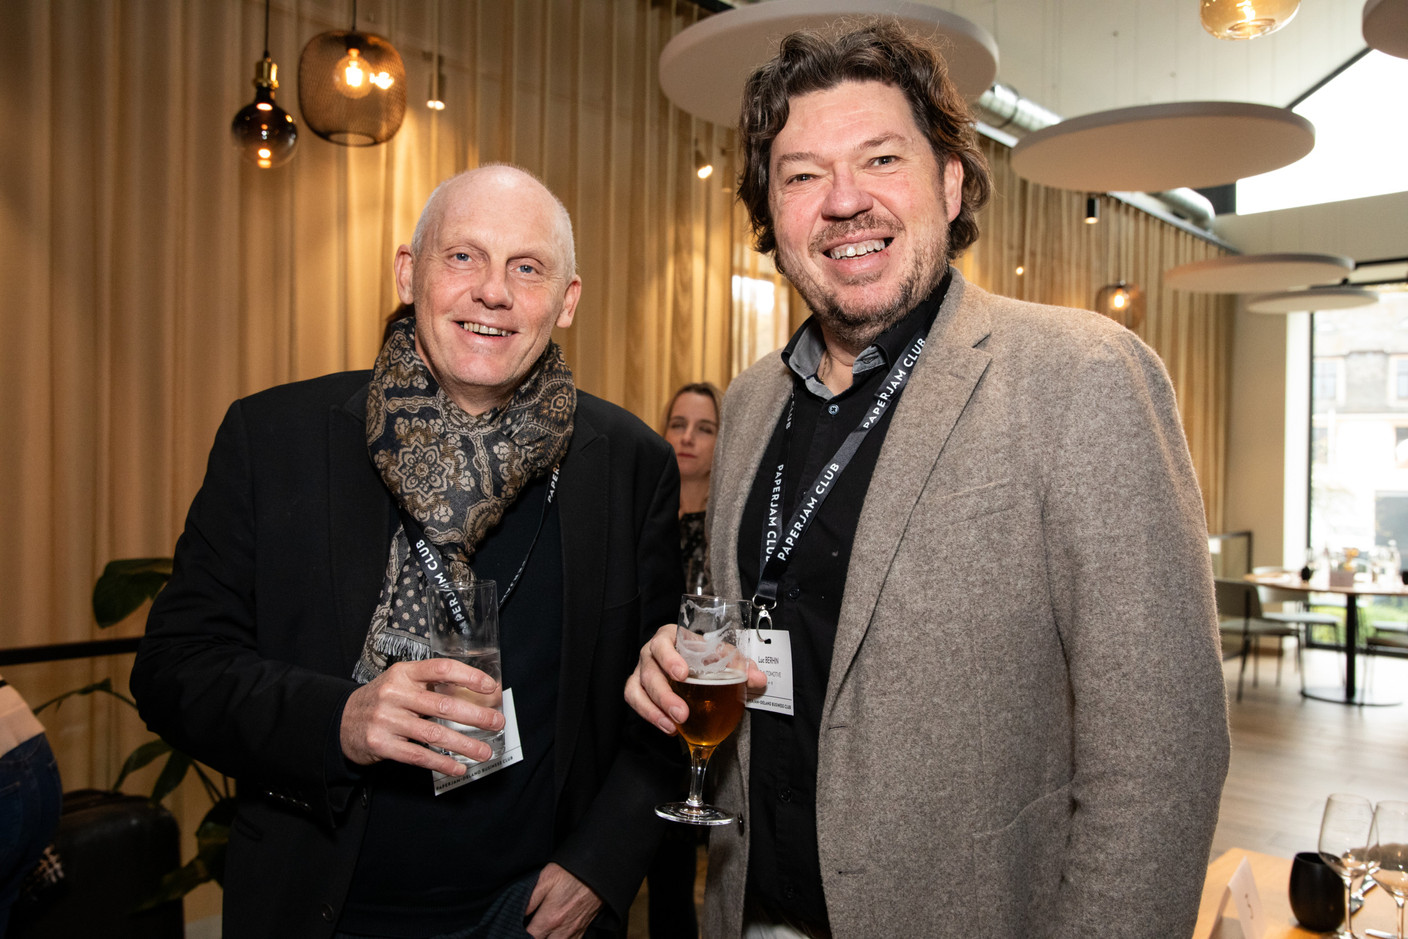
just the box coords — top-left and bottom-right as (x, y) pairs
(738, 20), (993, 262)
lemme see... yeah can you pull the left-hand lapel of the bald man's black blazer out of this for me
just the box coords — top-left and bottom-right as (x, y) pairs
(328, 389), (393, 676)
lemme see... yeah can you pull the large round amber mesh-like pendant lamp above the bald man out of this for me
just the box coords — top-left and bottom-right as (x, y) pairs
(298, 0), (406, 146)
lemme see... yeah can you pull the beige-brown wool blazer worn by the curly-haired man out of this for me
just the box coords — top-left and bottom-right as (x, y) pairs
(703, 272), (1228, 939)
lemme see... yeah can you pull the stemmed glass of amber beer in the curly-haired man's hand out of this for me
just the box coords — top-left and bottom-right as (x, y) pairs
(655, 594), (749, 825)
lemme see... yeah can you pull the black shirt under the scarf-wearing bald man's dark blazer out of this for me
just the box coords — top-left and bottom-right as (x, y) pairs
(338, 479), (562, 938)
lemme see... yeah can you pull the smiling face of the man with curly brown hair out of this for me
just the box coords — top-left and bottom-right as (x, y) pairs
(767, 82), (963, 353)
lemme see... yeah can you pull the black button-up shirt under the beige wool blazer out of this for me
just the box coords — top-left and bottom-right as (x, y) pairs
(738, 276), (949, 935)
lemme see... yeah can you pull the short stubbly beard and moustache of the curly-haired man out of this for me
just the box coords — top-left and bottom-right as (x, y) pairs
(774, 213), (949, 352)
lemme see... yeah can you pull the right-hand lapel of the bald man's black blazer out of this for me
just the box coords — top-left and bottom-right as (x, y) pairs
(553, 410), (611, 793)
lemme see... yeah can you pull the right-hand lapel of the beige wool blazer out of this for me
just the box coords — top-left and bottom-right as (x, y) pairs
(824, 272), (991, 712)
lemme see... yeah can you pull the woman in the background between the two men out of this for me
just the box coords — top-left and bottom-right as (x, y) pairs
(665, 382), (722, 593)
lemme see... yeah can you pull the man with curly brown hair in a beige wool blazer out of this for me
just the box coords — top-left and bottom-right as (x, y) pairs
(627, 23), (1228, 939)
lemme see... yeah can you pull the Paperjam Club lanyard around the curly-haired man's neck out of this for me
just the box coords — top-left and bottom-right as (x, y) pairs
(753, 329), (928, 629)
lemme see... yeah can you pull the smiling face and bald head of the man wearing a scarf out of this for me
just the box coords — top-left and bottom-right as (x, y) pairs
(396, 166), (582, 414)
